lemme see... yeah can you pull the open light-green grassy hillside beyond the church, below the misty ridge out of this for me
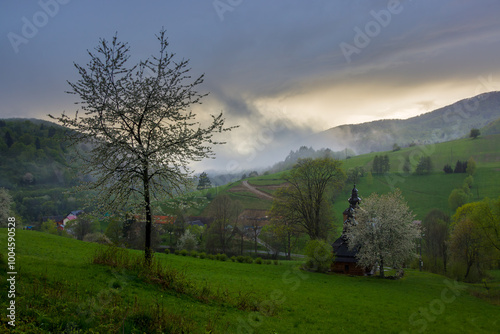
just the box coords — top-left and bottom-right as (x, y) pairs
(218, 134), (500, 219)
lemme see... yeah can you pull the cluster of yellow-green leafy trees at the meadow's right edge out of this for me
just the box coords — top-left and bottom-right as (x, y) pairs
(421, 198), (500, 282)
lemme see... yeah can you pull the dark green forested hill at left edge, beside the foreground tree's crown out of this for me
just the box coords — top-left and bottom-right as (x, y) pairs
(0, 119), (86, 225)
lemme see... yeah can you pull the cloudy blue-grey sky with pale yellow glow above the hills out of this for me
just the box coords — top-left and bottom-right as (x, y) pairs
(0, 0), (500, 172)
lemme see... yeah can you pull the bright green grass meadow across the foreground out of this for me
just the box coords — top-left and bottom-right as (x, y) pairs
(0, 229), (500, 333)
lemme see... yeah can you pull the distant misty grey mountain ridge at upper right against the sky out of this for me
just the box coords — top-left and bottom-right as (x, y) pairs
(304, 92), (500, 154)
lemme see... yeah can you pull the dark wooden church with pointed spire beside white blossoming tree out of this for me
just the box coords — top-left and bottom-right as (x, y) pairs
(331, 185), (368, 276)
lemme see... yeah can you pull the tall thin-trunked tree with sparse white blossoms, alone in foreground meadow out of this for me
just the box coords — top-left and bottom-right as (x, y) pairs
(50, 30), (231, 262)
